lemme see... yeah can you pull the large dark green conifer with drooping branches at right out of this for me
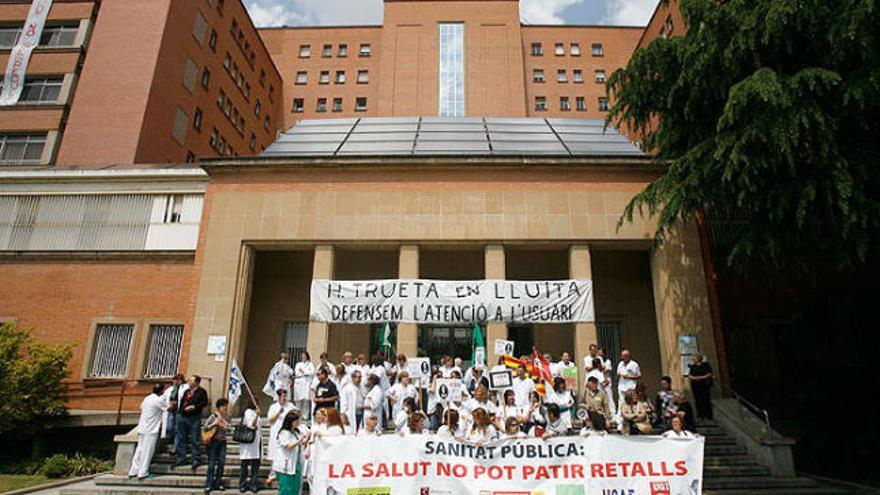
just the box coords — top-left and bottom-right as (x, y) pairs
(608, 0), (880, 269)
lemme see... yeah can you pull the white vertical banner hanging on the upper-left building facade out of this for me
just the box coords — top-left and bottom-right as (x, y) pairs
(0, 0), (52, 106)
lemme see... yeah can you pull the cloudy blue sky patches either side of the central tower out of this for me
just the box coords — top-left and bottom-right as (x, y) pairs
(245, 0), (658, 27)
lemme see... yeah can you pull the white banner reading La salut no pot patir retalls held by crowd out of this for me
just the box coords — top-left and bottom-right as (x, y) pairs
(311, 435), (705, 495)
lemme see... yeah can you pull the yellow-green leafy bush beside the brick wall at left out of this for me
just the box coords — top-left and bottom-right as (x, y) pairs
(0, 323), (73, 435)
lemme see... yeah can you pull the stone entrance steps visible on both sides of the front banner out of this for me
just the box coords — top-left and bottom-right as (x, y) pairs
(61, 423), (851, 495)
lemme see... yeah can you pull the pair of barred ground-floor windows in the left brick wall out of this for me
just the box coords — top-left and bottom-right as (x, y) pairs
(88, 323), (183, 379)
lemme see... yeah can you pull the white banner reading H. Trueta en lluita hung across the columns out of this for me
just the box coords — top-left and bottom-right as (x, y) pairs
(310, 279), (595, 324)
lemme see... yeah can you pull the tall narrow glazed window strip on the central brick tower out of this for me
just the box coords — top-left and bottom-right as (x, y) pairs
(439, 23), (464, 117)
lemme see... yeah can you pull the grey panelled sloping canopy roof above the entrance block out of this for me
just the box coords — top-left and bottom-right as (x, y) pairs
(261, 117), (646, 157)
